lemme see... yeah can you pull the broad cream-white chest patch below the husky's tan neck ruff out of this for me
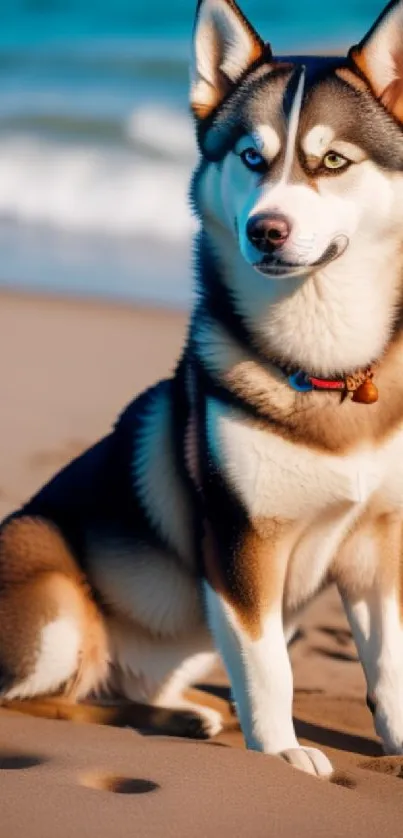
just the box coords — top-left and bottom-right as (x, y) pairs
(208, 399), (403, 521)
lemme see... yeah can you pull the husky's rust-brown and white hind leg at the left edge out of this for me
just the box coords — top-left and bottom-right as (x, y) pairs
(0, 517), (108, 701)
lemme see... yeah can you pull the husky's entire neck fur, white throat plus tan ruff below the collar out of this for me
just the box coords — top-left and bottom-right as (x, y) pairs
(187, 217), (403, 453)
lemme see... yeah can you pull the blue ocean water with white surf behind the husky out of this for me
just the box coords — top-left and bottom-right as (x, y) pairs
(0, 0), (382, 305)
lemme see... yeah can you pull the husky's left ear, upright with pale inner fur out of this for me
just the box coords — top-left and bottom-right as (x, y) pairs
(190, 0), (269, 119)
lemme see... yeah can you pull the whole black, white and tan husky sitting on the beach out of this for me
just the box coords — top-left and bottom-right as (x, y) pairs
(0, 0), (403, 776)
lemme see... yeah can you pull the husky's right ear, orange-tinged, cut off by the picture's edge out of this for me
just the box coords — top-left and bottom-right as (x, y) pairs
(350, 0), (403, 122)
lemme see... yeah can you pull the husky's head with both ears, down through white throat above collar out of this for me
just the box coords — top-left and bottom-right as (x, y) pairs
(191, 0), (403, 374)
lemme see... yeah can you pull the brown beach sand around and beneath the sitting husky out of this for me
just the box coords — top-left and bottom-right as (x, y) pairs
(0, 294), (403, 838)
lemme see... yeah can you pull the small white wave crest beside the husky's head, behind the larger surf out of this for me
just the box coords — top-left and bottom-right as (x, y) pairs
(126, 104), (196, 161)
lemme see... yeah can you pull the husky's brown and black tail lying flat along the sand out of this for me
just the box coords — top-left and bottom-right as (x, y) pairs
(0, 698), (210, 739)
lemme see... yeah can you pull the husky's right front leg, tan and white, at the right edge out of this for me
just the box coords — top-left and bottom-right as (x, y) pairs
(337, 516), (403, 754)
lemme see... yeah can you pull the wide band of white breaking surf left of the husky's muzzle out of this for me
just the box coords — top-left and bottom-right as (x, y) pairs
(0, 136), (194, 240)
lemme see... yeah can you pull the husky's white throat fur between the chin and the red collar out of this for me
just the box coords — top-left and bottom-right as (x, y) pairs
(201, 221), (403, 377)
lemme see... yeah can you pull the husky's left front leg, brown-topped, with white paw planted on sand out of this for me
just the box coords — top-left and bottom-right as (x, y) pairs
(205, 524), (332, 776)
